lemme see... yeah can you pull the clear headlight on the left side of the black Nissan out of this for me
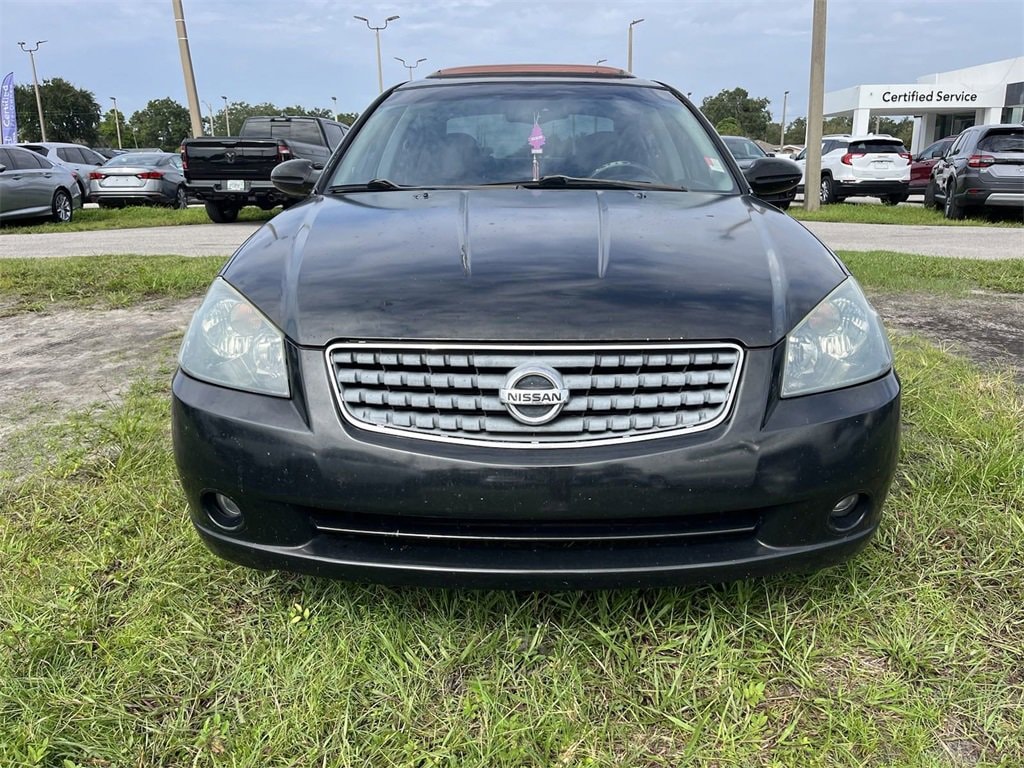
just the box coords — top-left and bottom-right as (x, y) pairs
(178, 278), (290, 397)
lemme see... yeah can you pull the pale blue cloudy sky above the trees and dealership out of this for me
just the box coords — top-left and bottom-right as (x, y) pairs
(0, 0), (1024, 120)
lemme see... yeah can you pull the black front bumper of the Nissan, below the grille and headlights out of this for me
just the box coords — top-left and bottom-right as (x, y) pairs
(172, 350), (899, 589)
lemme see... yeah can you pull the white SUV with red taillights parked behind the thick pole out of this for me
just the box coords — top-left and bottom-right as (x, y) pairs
(795, 133), (910, 205)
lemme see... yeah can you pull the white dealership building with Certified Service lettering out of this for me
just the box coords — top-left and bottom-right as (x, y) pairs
(824, 56), (1024, 153)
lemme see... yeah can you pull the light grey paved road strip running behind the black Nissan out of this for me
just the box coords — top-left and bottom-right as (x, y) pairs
(0, 221), (1024, 259)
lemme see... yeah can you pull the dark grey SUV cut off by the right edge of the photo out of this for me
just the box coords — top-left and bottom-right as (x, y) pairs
(925, 123), (1024, 219)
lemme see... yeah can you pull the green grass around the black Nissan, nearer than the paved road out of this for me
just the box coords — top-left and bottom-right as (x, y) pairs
(0, 254), (1024, 768)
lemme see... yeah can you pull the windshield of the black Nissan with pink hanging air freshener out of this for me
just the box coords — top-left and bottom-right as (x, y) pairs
(329, 81), (736, 193)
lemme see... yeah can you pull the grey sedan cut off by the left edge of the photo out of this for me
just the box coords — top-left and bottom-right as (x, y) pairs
(0, 144), (82, 222)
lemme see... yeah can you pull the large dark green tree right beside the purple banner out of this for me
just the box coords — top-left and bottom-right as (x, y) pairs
(14, 78), (99, 144)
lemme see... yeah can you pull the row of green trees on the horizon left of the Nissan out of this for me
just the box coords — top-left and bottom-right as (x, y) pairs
(14, 78), (356, 152)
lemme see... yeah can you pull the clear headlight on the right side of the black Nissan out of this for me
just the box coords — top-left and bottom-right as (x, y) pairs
(782, 278), (893, 397)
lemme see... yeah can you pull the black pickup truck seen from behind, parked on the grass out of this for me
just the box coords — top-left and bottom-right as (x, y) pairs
(181, 115), (348, 223)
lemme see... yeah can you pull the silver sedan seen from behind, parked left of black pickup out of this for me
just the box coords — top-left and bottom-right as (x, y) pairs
(89, 152), (188, 208)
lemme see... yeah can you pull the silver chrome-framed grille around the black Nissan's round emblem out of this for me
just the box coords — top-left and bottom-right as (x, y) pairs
(327, 343), (742, 447)
